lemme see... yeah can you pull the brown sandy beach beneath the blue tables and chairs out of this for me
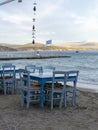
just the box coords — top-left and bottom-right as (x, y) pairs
(0, 90), (98, 130)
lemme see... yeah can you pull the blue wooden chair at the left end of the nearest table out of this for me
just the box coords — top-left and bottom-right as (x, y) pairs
(20, 70), (40, 109)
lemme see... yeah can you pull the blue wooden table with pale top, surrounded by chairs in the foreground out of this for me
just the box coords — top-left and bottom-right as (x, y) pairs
(30, 72), (76, 108)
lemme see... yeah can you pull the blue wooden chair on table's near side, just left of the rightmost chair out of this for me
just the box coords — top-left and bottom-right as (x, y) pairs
(45, 71), (68, 110)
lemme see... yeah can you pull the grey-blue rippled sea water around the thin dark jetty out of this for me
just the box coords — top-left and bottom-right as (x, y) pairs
(0, 50), (98, 90)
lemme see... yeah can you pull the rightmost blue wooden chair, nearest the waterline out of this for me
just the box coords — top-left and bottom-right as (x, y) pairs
(65, 71), (79, 107)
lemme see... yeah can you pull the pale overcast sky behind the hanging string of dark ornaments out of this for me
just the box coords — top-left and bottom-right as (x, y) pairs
(0, 0), (98, 44)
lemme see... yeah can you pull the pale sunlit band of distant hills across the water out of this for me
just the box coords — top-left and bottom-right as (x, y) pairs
(0, 41), (98, 51)
